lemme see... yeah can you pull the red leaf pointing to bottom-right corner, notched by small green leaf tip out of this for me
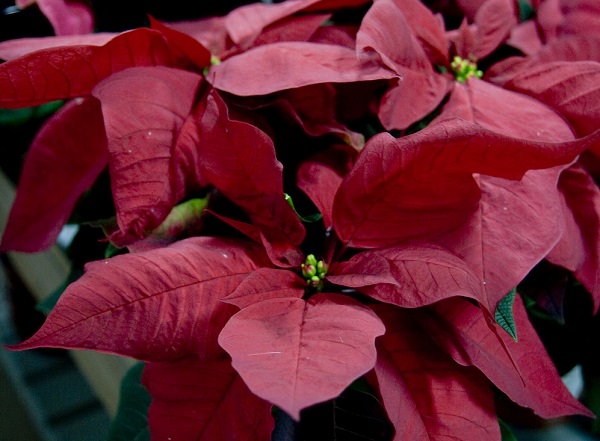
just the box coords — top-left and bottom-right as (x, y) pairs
(418, 296), (591, 418)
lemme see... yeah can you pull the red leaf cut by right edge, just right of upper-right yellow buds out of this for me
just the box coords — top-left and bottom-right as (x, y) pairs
(496, 61), (600, 136)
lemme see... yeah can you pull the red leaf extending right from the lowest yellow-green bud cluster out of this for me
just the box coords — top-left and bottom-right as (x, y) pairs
(327, 242), (487, 308)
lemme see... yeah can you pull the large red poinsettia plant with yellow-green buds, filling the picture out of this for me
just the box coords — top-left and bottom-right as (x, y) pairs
(0, 0), (600, 441)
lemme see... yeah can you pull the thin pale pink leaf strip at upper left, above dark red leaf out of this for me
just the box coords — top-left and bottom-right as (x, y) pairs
(0, 32), (117, 61)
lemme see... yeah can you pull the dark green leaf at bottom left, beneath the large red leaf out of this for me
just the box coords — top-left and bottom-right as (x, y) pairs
(107, 362), (151, 441)
